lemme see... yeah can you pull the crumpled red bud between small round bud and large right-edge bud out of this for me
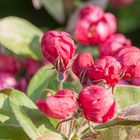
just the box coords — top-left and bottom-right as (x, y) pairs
(87, 56), (121, 85)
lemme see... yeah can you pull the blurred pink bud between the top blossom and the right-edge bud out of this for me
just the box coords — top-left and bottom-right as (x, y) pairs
(99, 33), (131, 56)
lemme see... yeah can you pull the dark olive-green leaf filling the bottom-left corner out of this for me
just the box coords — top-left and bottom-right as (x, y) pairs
(0, 124), (30, 140)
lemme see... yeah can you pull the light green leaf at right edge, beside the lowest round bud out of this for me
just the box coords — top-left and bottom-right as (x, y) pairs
(114, 85), (140, 111)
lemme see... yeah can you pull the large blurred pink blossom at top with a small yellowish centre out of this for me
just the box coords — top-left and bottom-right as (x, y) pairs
(75, 7), (117, 44)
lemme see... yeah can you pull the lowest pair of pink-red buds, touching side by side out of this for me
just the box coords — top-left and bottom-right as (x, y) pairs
(37, 85), (117, 123)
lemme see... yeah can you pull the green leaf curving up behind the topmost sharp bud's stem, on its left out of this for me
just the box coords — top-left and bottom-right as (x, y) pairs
(27, 65), (56, 102)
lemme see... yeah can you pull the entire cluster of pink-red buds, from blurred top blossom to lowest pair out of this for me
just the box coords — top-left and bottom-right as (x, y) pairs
(37, 5), (140, 123)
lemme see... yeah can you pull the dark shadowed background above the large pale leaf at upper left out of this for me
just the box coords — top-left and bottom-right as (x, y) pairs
(0, 0), (60, 28)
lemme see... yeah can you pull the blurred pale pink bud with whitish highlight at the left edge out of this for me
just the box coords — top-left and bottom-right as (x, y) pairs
(0, 72), (17, 89)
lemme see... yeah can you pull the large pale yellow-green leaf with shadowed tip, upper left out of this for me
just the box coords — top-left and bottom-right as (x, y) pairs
(0, 17), (42, 59)
